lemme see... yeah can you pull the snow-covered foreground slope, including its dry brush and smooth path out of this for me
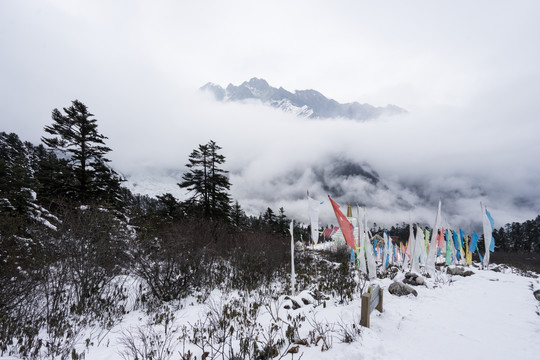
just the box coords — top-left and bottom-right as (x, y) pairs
(0, 247), (540, 360)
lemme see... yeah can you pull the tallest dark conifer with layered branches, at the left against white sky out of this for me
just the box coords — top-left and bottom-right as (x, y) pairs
(41, 100), (122, 205)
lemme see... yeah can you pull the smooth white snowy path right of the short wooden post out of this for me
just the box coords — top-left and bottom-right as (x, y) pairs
(362, 271), (540, 359)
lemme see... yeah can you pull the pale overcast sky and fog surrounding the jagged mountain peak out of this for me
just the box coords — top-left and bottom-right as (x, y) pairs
(0, 0), (540, 226)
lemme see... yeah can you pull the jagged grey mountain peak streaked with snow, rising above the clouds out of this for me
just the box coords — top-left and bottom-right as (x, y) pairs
(201, 77), (406, 121)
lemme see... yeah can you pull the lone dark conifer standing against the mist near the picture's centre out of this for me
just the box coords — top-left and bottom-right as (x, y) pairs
(178, 140), (231, 219)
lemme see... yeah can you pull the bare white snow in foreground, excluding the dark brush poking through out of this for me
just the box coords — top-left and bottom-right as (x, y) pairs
(0, 267), (540, 360)
